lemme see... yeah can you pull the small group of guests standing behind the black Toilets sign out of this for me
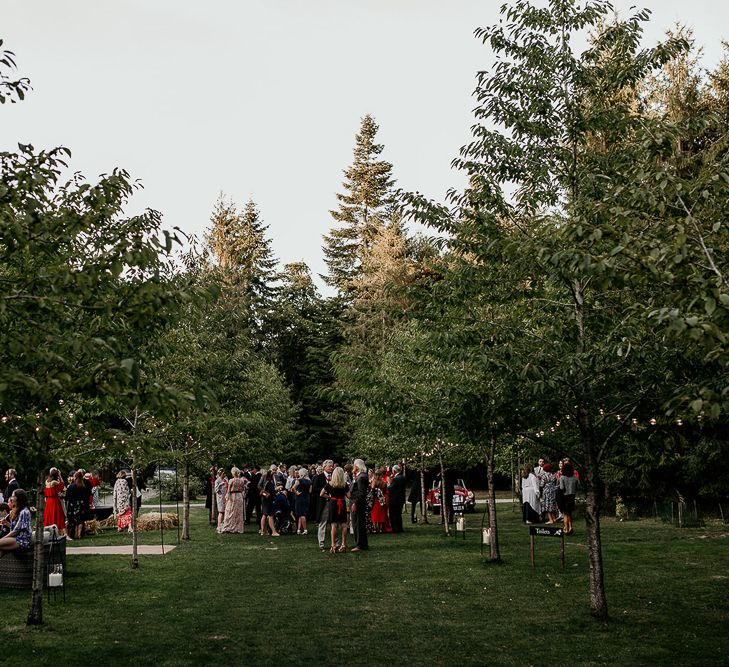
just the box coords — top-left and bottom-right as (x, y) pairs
(521, 458), (580, 535)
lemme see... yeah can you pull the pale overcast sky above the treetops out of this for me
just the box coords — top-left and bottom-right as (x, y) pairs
(0, 0), (729, 287)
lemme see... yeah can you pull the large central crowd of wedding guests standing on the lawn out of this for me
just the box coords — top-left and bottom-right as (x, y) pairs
(209, 459), (405, 553)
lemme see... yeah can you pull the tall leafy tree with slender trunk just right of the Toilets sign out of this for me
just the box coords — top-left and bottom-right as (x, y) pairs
(438, 0), (685, 618)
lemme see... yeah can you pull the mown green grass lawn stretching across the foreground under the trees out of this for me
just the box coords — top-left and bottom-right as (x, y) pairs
(0, 504), (729, 667)
